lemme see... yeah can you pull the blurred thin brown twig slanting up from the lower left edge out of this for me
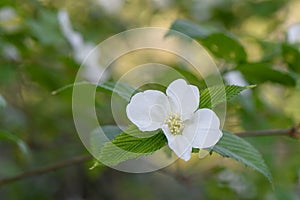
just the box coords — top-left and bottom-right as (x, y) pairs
(0, 155), (92, 187)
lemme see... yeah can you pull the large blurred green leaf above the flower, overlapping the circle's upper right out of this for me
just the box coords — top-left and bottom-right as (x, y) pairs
(167, 20), (247, 62)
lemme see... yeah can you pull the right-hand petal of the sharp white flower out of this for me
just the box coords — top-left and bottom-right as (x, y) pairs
(182, 108), (223, 148)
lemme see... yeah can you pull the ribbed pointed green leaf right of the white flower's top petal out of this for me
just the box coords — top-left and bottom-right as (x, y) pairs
(200, 85), (255, 108)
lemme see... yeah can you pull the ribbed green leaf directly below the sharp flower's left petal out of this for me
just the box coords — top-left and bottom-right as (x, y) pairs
(99, 126), (167, 166)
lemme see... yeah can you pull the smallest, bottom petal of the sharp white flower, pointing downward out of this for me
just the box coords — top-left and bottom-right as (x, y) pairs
(162, 125), (192, 161)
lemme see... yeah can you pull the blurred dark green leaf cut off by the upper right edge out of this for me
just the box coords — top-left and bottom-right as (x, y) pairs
(281, 44), (300, 73)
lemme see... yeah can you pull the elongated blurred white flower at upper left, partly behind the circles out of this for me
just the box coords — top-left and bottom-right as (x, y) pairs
(58, 10), (108, 84)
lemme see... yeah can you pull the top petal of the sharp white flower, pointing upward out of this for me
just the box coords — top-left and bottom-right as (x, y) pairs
(166, 79), (199, 120)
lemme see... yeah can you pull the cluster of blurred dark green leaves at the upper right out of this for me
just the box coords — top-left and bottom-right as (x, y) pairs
(169, 19), (300, 87)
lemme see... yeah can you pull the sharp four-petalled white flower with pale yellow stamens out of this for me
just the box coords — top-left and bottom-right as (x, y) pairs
(126, 79), (222, 161)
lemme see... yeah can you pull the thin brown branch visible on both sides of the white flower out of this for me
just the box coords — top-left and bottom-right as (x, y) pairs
(0, 124), (300, 187)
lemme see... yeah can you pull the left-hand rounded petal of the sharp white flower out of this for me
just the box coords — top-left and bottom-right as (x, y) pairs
(126, 90), (170, 131)
